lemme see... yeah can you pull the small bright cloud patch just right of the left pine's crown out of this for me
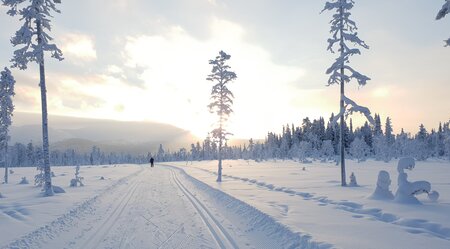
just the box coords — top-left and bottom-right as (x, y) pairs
(60, 33), (97, 62)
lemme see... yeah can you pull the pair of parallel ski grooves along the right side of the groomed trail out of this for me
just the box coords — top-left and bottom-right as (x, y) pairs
(171, 169), (239, 249)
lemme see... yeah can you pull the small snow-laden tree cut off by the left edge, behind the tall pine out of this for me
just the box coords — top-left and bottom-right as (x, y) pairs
(0, 67), (16, 183)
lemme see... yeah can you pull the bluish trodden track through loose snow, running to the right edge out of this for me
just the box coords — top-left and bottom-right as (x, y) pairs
(193, 167), (450, 240)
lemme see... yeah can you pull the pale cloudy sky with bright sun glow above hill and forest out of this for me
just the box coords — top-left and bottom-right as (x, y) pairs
(0, 0), (450, 138)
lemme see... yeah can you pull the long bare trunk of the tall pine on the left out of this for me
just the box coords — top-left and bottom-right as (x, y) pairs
(36, 21), (54, 196)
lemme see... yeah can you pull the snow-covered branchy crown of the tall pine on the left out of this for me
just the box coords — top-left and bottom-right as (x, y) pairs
(2, 0), (63, 70)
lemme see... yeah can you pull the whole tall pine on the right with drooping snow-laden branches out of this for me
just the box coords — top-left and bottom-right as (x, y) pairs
(322, 0), (373, 186)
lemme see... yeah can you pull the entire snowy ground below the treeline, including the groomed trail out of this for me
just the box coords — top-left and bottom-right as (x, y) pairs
(0, 160), (450, 249)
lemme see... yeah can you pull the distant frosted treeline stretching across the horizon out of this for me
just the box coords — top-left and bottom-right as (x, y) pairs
(8, 114), (450, 167)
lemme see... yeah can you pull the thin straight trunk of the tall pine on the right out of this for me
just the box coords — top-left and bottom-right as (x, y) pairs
(339, 7), (347, 186)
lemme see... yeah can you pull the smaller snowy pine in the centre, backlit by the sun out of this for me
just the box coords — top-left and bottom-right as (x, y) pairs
(206, 51), (237, 182)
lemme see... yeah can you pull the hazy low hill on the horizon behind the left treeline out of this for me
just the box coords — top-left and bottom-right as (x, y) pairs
(10, 112), (199, 154)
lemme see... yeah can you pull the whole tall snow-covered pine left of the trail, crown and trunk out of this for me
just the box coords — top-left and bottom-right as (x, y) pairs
(2, 0), (63, 196)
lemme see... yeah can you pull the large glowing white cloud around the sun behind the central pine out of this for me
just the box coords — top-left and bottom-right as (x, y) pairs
(124, 18), (305, 136)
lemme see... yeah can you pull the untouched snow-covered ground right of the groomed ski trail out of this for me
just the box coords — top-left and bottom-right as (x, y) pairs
(170, 160), (450, 249)
